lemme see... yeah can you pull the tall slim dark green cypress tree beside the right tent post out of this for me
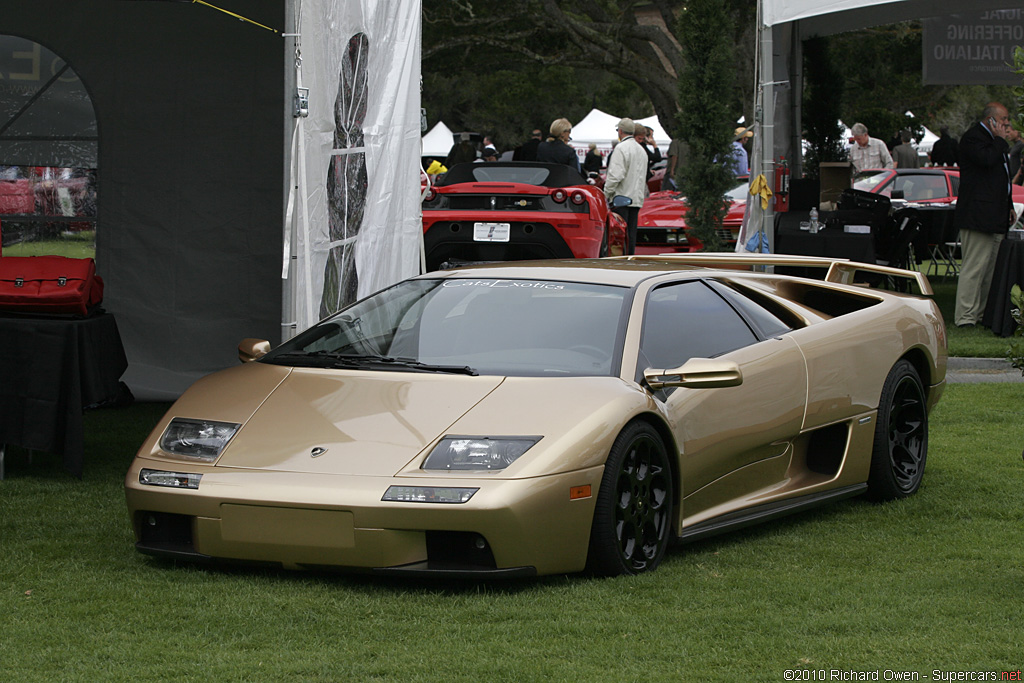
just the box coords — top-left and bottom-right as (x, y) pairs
(678, 0), (735, 251)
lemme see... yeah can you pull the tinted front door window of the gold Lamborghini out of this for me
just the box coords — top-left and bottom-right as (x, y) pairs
(640, 281), (758, 368)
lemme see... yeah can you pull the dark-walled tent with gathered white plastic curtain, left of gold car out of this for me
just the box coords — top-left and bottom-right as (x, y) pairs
(0, 0), (421, 399)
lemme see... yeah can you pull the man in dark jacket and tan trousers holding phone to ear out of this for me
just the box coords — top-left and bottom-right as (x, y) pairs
(953, 102), (1016, 328)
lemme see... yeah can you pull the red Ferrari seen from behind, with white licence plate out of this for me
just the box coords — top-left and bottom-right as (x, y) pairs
(423, 162), (626, 270)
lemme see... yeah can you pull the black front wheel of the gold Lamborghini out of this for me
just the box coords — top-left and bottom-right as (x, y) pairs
(587, 422), (673, 577)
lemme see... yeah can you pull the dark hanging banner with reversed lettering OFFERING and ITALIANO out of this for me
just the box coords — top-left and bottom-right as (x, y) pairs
(922, 7), (1024, 85)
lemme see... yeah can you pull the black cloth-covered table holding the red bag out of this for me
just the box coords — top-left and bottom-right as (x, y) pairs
(0, 313), (128, 478)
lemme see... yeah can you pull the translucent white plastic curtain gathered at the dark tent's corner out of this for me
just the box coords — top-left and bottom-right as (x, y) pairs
(282, 0), (423, 339)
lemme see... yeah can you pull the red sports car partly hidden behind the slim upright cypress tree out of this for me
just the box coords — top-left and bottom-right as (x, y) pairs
(637, 178), (748, 254)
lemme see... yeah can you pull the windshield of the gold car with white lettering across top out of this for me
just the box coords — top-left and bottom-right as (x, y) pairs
(263, 278), (630, 377)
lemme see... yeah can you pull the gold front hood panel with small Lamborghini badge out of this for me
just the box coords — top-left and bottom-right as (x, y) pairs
(217, 369), (504, 476)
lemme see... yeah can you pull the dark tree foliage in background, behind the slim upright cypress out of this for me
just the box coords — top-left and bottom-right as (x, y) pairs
(423, 0), (757, 135)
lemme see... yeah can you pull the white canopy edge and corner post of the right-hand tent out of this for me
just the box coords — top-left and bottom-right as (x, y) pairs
(741, 0), (1013, 252)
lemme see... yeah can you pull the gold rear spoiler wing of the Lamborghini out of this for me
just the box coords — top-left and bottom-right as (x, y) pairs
(608, 252), (934, 296)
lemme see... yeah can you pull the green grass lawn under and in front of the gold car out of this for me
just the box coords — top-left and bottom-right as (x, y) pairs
(0, 384), (1024, 683)
